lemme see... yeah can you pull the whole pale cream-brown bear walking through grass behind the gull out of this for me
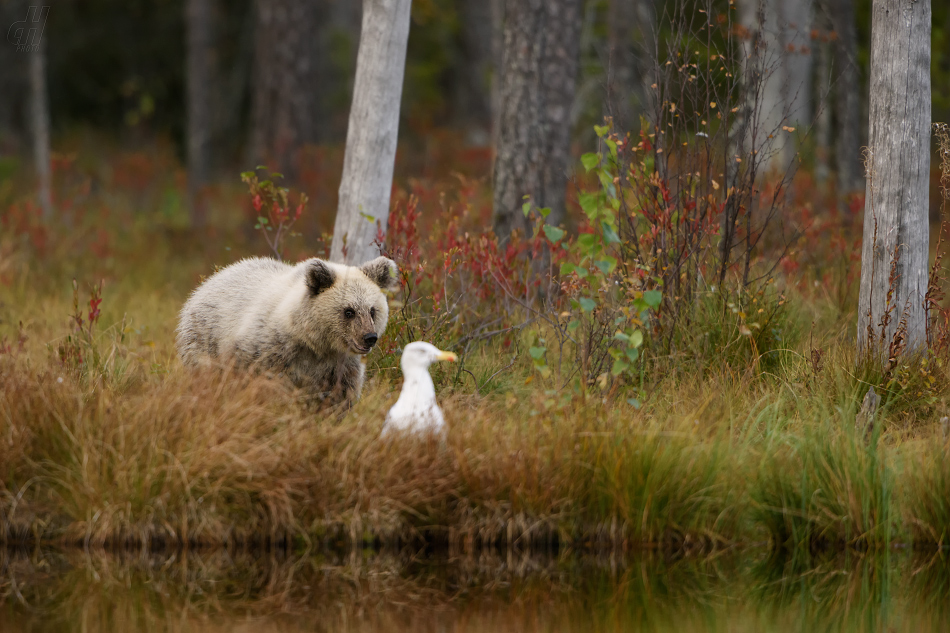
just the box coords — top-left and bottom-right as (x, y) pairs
(177, 257), (398, 403)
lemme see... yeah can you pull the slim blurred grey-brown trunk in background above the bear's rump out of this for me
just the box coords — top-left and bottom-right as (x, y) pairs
(185, 0), (213, 226)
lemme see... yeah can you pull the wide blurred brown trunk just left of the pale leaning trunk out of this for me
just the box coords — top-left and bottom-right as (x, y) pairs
(248, 0), (326, 178)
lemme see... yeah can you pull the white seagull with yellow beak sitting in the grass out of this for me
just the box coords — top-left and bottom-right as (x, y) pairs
(383, 341), (458, 436)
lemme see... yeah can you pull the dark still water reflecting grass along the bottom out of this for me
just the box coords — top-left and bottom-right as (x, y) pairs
(0, 550), (950, 633)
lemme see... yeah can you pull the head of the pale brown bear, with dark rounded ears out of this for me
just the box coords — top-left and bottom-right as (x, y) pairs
(303, 257), (399, 354)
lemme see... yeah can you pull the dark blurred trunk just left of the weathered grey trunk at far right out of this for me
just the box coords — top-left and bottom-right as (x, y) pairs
(826, 0), (865, 195)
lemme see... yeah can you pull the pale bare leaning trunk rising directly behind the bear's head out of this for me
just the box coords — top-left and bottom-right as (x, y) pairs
(330, 0), (412, 264)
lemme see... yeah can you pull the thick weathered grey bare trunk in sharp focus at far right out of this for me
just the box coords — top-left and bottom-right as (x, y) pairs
(858, 0), (931, 354)
